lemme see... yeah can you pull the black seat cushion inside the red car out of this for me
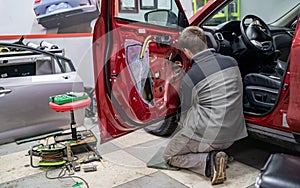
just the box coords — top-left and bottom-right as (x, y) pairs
(244, 73), (281, 112)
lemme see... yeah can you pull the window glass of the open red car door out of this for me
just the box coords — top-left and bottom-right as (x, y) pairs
(117, 0), (179, 28)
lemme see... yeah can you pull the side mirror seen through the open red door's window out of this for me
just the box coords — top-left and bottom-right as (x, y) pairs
(144, 10), (178, 26)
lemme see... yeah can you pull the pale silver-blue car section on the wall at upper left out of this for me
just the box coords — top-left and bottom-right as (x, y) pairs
(34, 0), (99, 28)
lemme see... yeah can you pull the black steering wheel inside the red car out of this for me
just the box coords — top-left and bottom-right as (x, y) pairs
(240, 14), (274, 53)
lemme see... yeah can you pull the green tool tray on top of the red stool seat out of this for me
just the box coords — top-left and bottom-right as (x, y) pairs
(49, 92), (88, 104)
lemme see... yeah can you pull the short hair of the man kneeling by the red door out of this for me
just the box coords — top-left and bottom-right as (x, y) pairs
(178, 26), (207, 54)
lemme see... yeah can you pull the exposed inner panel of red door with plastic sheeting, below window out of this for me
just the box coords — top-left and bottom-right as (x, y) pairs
(110, 24), (185, 126)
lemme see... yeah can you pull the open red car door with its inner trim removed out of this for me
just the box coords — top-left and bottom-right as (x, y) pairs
(93, 0), (193, 142)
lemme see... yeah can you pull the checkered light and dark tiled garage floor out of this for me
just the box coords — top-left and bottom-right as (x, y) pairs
(0, 119), (288, 188)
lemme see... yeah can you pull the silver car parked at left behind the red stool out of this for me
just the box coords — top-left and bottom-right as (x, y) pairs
(0, 43), (84, 144)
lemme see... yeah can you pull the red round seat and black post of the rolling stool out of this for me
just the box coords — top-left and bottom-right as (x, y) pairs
(49, 94), (91, 141)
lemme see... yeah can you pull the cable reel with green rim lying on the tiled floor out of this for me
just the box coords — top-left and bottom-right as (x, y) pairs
(29, 144), (67, 168)
